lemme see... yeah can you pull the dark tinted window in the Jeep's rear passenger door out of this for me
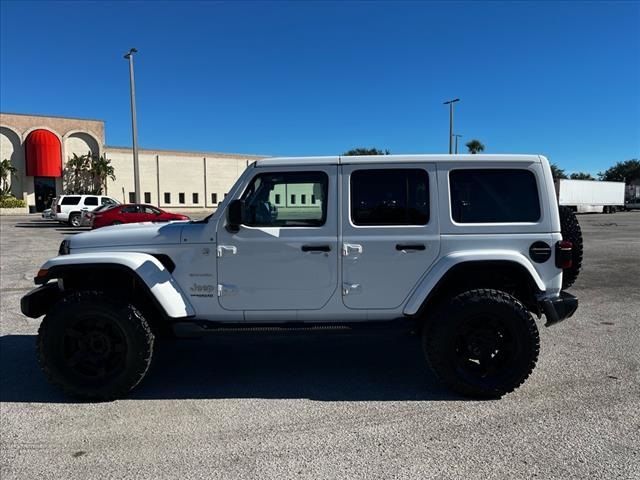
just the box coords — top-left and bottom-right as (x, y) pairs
(351, 168), (429, 225)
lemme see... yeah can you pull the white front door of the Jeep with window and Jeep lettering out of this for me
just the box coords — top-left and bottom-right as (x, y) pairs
(217, 165), (339, 312)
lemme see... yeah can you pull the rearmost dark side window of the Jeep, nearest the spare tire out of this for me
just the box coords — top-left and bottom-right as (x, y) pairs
(449, 169), (540, 223)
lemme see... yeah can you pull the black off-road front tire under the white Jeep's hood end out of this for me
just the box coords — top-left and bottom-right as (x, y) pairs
(36, 292), (155, 400)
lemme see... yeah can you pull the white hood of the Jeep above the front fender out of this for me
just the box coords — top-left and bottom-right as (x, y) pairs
(67, 222), (187, 253)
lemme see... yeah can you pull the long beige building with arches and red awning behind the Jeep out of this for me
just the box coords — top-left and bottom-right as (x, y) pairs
(0, 113), (263, 211)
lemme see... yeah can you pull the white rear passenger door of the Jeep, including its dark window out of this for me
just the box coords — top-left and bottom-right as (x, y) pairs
(341, 163), (440, 309)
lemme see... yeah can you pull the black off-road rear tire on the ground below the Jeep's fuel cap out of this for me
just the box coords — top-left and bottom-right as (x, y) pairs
(422, 289), (540, 399)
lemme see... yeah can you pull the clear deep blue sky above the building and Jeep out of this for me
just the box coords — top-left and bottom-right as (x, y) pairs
(0, 0), (640, 173)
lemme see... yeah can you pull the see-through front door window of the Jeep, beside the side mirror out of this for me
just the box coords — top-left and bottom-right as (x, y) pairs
(242, 172), (329, 227)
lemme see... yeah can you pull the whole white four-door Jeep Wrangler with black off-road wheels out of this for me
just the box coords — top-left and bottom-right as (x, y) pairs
(21, 155), (582, 399)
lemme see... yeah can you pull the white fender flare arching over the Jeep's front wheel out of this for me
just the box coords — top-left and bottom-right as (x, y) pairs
(37, 252), (195, 318)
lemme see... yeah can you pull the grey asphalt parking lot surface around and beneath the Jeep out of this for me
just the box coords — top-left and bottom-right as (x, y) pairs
(0, 212), (640, 480)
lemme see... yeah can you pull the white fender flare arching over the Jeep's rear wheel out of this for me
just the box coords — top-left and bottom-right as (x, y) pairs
(403, 250), (546, 316)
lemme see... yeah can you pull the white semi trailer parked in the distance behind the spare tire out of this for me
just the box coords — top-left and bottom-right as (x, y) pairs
(556, 180), (624, 213)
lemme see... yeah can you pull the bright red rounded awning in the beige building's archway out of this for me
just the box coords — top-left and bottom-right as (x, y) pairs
(25, 130), (62, 177)
